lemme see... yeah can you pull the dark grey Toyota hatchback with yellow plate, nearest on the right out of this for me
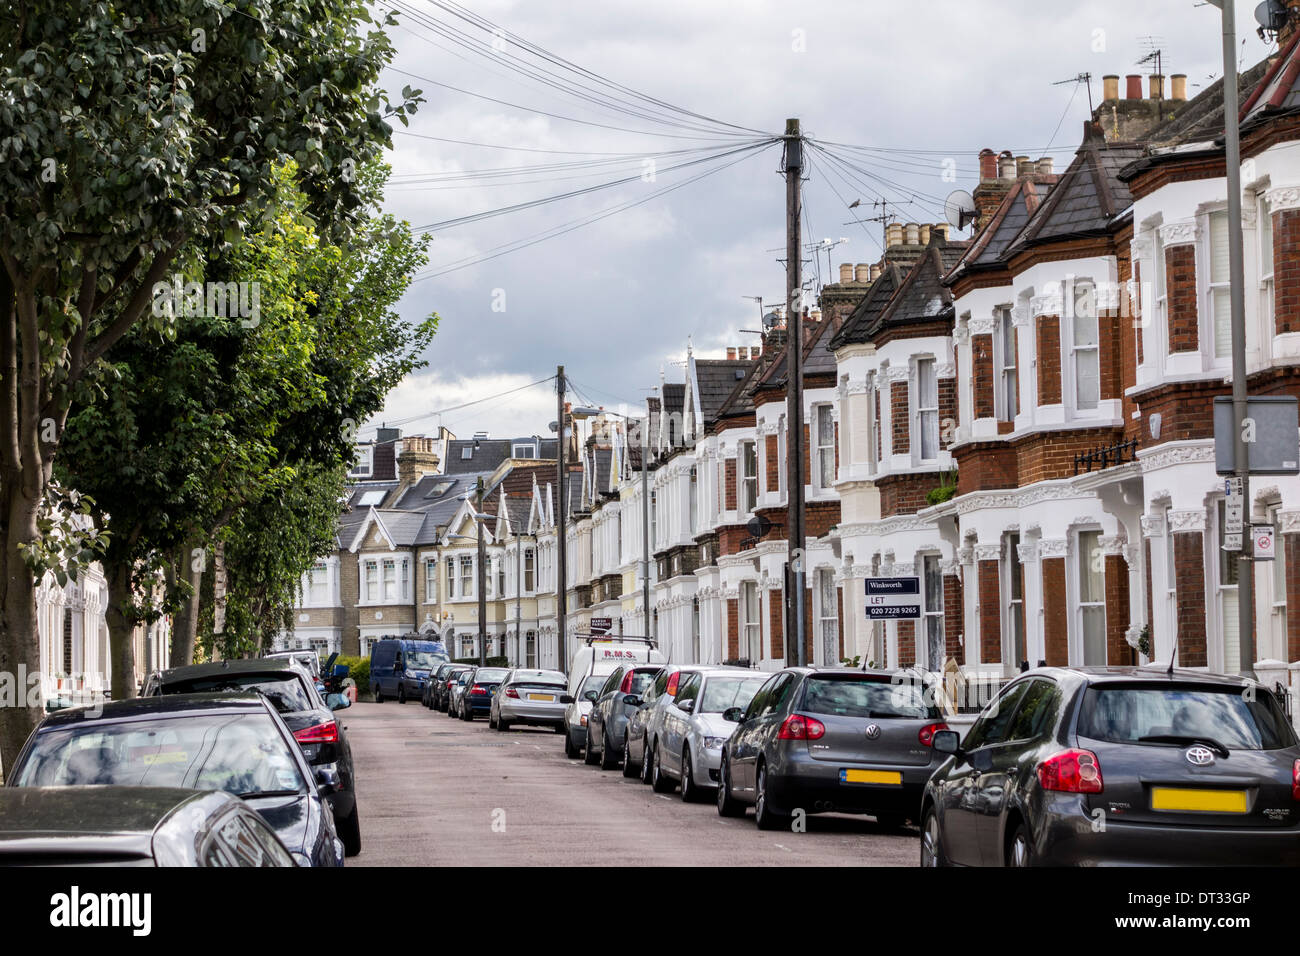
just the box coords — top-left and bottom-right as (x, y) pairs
(920, 667), (1300, 866)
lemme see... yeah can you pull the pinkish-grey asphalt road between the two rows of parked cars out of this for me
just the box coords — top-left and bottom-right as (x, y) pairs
(341, 701), (919, 866)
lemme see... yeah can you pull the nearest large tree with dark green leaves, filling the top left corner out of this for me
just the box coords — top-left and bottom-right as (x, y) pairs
(0, 0), (419, 761)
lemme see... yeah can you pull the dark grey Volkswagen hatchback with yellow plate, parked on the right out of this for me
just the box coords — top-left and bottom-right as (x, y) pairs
(718, 667), (948, 830)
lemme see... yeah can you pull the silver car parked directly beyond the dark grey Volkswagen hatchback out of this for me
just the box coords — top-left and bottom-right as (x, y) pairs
(651, 667), (768, 803)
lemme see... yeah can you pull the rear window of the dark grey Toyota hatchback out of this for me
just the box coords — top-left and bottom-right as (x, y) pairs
(1078, 684), (1295, 750)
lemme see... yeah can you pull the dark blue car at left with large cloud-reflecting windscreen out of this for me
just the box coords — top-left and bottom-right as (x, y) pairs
(7, 693), (343, 866)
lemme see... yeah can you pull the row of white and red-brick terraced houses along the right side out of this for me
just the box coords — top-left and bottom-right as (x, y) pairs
(286, 34), (1300, 712)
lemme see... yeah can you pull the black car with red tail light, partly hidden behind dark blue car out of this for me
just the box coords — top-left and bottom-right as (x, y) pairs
(140, 658), (361, 856)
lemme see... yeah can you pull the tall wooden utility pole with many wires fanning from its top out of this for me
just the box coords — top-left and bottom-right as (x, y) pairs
(784, 120), (806, 666)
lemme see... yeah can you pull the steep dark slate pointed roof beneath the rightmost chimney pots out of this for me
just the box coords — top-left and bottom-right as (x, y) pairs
(1004, 122), (1145, 258)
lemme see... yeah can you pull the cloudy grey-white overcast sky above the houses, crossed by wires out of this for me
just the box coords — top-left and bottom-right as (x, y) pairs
(363, 0), (1269, 437)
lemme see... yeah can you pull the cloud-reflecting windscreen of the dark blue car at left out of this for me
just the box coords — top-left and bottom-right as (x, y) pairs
(17, 711), (306, 796)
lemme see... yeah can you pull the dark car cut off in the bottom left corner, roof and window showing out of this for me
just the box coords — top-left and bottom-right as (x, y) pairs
(0, 787), (296, 866)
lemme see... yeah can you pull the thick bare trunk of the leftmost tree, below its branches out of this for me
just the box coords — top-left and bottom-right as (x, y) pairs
(0, 484), (44, 770)
